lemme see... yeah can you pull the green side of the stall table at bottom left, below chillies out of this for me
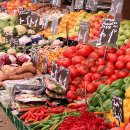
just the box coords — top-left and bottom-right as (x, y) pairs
(0, 103), (30, 130)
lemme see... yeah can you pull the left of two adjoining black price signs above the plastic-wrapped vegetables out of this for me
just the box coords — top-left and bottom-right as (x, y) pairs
(51, 61), (59, 81)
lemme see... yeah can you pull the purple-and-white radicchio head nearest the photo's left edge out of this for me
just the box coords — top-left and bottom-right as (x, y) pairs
(1, 54), (17, 65)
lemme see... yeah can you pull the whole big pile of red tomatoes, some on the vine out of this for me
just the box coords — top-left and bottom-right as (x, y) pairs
(52, 39), (130, 100)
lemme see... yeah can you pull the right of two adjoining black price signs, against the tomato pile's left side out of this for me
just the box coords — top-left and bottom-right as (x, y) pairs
(59, 66), (70, 89)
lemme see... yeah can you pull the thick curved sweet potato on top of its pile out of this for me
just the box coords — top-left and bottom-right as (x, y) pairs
(15, 65), (37, 74)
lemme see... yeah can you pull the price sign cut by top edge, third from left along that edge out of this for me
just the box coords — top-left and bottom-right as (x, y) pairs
(86, 0), (98, 11)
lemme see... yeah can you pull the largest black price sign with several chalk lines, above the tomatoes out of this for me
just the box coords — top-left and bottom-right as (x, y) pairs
(99, 18), (121, 44)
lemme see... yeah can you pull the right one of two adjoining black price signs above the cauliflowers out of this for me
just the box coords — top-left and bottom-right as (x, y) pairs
(30, 12), (40, 27)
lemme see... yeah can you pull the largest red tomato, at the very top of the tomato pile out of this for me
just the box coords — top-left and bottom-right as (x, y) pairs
(77, 45), (91, 56)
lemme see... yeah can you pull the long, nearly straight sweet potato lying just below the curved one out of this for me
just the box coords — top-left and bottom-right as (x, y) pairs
(8, 72), (33, 80)
